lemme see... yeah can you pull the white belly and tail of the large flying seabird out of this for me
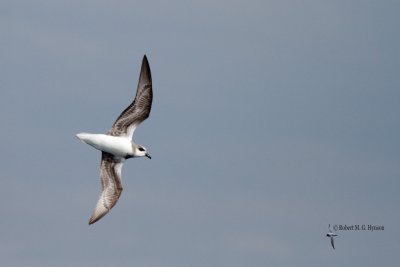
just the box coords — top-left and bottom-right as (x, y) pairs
(77, 133), (132, 157)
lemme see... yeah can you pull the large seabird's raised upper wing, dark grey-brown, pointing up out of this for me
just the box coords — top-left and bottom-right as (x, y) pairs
(107, 55), (153, 138)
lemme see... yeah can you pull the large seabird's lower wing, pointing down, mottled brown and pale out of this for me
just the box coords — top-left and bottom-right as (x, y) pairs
(89, 152), (123, 224)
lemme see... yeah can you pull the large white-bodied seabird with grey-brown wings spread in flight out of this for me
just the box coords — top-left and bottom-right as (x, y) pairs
(76, 55), (153, 224)
